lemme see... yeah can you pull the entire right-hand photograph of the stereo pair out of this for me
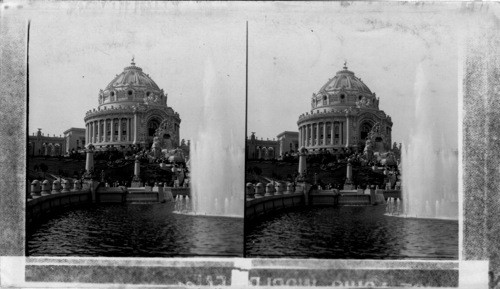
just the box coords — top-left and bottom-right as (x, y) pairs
(245, 3), (458, 260)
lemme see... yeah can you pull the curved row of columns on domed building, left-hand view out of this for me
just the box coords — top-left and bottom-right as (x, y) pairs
(85, 115), (137, 144)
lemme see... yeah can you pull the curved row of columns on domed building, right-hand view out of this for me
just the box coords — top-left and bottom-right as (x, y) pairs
(299, 118), (351, 147)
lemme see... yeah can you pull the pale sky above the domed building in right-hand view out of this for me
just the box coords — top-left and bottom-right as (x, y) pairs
(244, 3), (464, 148)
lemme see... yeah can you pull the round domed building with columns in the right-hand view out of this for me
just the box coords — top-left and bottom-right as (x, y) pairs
(297, 64), (392, 152)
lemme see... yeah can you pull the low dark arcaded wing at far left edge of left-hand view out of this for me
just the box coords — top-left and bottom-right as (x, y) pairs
(28, 128), (66, 156)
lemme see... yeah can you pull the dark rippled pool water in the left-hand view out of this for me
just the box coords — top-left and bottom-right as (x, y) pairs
(27, 203), (243, 257)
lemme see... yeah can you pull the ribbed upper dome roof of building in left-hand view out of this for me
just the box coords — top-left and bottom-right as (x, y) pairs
(105, 60), (160, 90)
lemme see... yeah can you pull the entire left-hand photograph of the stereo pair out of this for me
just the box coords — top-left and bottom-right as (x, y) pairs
(26, 3), (246, 257)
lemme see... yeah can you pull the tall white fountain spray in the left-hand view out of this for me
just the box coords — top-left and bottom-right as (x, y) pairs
(178, 57), (245, 218)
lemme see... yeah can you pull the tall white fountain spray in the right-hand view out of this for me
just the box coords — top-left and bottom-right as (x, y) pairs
(401, 63), (458, 220)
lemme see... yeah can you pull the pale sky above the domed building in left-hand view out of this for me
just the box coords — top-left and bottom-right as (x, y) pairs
(29, 2), (246, 140)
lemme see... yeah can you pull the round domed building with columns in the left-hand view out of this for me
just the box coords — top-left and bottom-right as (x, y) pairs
(84, 59), (181, 149)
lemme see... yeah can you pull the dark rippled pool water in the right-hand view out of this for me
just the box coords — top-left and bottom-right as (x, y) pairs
(246, 206), (458, 259)
